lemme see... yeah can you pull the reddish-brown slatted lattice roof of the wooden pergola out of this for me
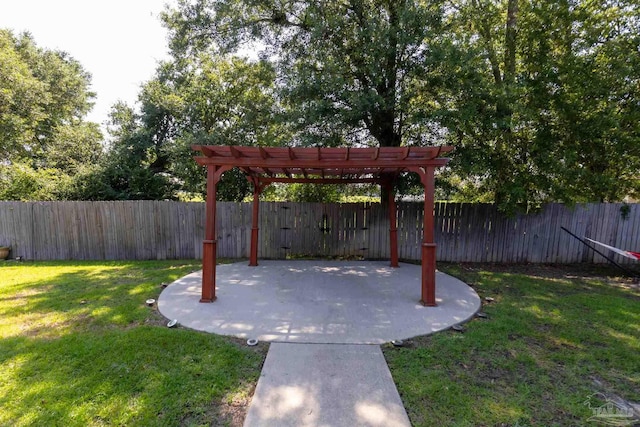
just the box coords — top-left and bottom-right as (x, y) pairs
(192, 145), (453, 183)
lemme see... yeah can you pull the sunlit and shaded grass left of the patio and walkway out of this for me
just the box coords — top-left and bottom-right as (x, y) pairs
(0, 261), (266, 426)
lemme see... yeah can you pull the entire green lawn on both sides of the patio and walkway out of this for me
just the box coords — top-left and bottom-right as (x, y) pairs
(0, 261), (640, 426)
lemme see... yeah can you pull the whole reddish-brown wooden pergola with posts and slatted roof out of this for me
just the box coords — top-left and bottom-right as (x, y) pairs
(192, 145), (453, 306)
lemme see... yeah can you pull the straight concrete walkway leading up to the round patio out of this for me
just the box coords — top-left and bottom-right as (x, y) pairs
(244, 343), (411, 427)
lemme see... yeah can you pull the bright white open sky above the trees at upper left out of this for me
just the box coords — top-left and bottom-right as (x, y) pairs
(0, 0), (171, 129)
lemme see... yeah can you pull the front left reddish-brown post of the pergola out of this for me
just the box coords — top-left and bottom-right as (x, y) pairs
(200, 165), (230, 302)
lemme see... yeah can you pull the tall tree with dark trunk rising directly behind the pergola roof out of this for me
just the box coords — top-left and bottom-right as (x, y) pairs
(164, 0), (442, 150)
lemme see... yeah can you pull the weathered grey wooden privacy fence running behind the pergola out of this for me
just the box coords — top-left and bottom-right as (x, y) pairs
(0, 201), (640, 263)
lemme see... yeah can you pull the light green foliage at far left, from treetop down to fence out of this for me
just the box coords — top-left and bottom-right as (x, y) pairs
(0, 29), (102, 200)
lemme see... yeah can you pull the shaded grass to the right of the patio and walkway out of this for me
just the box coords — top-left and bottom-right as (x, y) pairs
(383, 265), (640, 426)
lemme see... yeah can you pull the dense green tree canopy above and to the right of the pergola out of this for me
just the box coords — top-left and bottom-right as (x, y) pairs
(159, 0), (640, 211)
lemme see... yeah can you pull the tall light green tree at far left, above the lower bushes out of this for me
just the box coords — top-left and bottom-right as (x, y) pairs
(0, 30), (99, 166)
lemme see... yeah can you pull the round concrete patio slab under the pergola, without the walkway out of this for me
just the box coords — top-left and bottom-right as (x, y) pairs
(158, 260), (480, 344)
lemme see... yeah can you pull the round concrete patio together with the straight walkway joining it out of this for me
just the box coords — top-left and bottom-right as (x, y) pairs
(158, 260), (480, 427)
